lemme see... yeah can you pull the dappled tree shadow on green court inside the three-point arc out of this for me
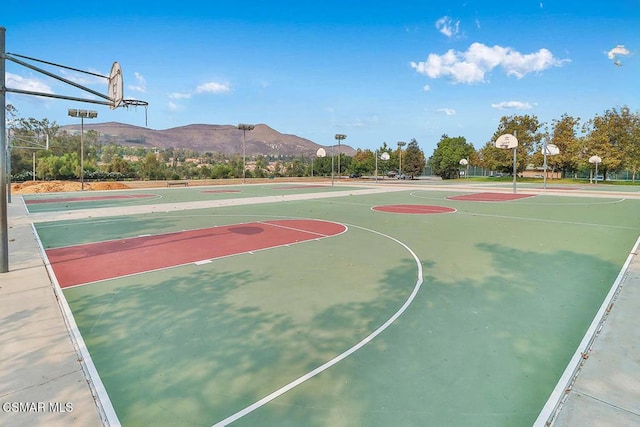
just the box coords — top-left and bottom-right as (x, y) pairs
(65, 254), (417, 425)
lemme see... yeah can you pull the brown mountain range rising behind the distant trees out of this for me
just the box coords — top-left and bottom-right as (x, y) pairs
(60, 122), (356, 156)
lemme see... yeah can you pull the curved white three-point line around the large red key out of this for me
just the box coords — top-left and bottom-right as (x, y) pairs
(213, 224), (424, 427)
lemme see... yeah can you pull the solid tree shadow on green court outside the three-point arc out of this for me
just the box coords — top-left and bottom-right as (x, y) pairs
(318, 244), (620, 426)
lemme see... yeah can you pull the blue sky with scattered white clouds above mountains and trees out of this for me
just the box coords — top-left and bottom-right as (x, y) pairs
(0, 0), (640, 156)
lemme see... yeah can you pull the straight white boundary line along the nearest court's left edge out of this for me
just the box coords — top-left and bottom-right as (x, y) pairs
(31, 223), (121, 427)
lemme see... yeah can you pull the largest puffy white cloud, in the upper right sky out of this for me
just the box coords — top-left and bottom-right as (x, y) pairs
(410, 43), (569, 84)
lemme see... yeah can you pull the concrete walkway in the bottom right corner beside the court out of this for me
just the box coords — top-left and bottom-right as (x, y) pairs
(536, 239), (640, 427)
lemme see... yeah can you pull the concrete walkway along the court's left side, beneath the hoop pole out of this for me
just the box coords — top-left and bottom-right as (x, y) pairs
(0, 197), (104, 427)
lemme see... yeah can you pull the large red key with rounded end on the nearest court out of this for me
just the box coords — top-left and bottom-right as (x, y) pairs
(46, 220), (347, 288)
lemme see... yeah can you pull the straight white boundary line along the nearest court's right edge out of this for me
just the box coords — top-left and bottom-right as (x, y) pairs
(533, 236), (640, 427)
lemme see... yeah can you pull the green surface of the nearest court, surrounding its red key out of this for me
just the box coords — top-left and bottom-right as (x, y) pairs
(36, 186), (640, 426)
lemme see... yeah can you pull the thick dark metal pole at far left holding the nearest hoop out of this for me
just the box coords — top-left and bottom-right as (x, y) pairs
(0, 27), (9, 273)
